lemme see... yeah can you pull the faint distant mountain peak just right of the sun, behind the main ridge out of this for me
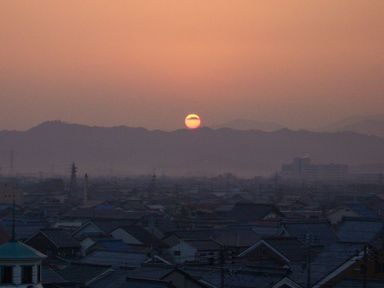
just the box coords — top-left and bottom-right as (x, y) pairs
(212, 119), (285, 132)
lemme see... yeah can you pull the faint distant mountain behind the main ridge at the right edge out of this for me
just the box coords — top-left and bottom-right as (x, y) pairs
(321, 115), (384, 137)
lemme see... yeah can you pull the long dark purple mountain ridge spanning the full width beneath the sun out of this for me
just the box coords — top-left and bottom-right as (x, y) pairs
(0, 121), (384, 176)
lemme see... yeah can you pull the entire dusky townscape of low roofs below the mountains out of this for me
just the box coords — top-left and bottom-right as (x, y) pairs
(0, 164), (384, 288)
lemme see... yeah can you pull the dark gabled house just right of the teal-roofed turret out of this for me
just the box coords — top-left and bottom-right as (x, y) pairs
(25, 228), (80, 258)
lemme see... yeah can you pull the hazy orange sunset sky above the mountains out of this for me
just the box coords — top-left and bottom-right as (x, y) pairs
(0, 0), (384, 129)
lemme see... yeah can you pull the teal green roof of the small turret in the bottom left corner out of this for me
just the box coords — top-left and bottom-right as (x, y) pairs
(0, 241), (46, 261)
